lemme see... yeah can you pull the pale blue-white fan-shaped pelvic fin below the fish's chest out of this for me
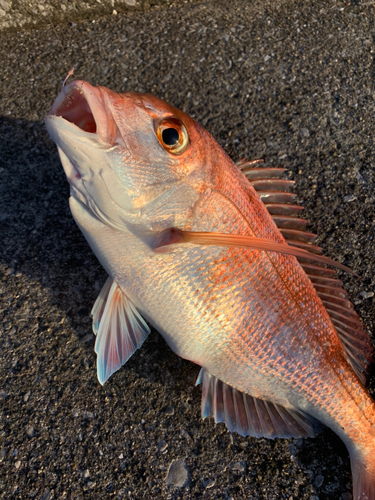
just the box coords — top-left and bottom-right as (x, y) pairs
(91, 278), (150, 385)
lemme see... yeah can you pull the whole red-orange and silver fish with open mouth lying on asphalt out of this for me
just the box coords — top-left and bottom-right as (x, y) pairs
(45, 80), (375, 500)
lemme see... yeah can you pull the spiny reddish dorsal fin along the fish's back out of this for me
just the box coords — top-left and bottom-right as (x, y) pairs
(237, 159), (373, 383)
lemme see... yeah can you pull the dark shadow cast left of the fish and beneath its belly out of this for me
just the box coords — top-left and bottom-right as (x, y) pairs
(0, 117), (197, 379)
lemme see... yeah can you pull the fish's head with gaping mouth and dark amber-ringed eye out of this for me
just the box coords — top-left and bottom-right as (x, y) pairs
(46, 80), (217, 231)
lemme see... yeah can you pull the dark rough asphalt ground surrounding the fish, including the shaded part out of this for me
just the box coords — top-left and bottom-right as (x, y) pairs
(0, 0), (375, 500)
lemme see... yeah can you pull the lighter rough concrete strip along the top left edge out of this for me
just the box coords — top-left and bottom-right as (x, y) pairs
(0, 0), (203, 31)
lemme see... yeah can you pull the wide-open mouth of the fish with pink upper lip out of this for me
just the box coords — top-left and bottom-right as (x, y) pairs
(47, 80), (113, 145)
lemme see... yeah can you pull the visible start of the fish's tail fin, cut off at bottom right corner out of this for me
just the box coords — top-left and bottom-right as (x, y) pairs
(350, 450), (375, 500)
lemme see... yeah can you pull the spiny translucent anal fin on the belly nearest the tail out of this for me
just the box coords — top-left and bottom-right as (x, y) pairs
(197, 368), (323, 438)
